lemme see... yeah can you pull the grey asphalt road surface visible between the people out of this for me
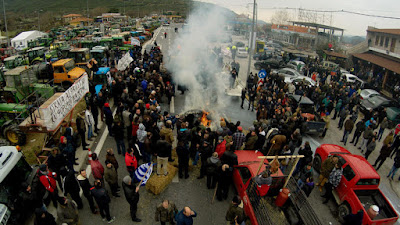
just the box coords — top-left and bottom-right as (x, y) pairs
(76, 24), (399, 225)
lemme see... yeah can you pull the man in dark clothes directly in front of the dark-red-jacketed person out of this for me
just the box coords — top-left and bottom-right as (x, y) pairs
(90, 179), (115, 223)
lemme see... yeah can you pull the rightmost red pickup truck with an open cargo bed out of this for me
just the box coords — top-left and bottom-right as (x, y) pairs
(313, 144), (399, 225)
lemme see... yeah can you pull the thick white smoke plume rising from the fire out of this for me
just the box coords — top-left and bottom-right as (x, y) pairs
(166, 5), (231, 121)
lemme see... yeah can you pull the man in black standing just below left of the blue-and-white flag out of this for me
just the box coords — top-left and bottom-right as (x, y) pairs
(122, 176), (142, 222)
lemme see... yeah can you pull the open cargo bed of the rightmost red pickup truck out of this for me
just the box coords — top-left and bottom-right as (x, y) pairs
(354, 190), (397, 220)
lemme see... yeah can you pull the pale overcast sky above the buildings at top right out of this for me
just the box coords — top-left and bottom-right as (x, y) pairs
(201, 0), (400, 36)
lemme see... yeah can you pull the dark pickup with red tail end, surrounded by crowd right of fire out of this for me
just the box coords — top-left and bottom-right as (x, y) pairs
(289, 95), (325, 134)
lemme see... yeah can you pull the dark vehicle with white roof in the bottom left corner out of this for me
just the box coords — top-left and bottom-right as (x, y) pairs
(0, 146), (44, 225)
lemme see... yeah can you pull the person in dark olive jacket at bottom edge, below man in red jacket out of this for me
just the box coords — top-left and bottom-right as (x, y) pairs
(57, 197), (80, 225)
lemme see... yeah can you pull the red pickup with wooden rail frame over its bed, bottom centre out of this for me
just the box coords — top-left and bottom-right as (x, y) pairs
(233, 150), (322, 225)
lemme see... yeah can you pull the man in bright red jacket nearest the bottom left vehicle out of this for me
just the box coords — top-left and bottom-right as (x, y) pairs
(39, 164), (58, 208)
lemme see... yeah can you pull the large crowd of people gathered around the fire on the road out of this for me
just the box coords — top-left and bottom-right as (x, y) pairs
(15, 34), (400, 225)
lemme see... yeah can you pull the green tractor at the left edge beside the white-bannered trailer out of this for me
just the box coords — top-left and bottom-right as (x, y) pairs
(0, 103), (29, 145)
